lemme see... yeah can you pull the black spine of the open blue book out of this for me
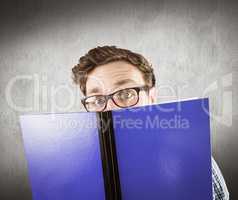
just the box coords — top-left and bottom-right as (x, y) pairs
(97, 111), (121, 200)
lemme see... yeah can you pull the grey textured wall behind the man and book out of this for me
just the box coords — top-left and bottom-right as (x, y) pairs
(0, 0), (238, 200)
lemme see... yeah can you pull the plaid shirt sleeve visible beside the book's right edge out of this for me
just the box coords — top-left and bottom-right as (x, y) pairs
(212, 158), (229, 200)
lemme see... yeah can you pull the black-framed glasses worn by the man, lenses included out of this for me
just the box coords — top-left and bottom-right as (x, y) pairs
(81, 86), (150, 112)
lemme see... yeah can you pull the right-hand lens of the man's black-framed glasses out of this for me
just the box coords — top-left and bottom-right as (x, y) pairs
(113, 89), (139, 108)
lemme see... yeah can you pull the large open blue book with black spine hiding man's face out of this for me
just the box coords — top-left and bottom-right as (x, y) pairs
(20, 98), (212, 200)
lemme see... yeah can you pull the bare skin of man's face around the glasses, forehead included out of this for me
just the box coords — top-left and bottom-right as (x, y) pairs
(86, 61), (155, 111)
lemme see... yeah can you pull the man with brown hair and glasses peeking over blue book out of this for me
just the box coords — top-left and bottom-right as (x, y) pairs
(72, 46), (229, 200)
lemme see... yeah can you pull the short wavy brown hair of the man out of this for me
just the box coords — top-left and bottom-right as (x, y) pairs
(72, 46), (155, 95)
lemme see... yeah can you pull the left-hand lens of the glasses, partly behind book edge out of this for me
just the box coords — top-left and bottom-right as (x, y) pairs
(85, 96), (106, 112)
